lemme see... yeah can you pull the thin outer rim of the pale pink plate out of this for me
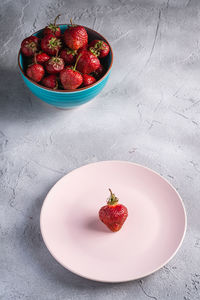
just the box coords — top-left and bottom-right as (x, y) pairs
(40, 160), (187, 283)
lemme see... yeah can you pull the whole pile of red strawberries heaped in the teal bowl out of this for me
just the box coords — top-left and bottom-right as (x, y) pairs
(21, 16), (110, 90)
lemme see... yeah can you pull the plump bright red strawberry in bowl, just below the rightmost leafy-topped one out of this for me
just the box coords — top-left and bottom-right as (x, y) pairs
(77, 50), (100, 74)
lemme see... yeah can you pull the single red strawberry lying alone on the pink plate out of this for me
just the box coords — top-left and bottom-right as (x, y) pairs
(99, 189), (128, 232)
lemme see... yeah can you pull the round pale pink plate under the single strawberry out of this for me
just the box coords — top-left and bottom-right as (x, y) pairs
(40, 161), (186, 282)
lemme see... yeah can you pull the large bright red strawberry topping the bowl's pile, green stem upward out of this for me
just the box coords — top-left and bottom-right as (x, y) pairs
(64, 20), (88, 50)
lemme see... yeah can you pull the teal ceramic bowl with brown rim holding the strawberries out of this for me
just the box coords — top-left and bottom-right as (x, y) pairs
(18, 25), (113, 108)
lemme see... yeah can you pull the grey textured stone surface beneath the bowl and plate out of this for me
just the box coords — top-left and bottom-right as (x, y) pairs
(0, 0), (200, 300)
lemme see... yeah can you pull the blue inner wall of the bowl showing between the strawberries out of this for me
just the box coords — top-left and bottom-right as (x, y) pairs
(19, 25), (112, 86)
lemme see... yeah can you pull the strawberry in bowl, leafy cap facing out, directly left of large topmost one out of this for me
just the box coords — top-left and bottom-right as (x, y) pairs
(41, 34), (62, 55)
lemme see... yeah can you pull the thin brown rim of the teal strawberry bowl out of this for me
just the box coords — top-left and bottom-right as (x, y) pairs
(18, 24), (113, 93)
